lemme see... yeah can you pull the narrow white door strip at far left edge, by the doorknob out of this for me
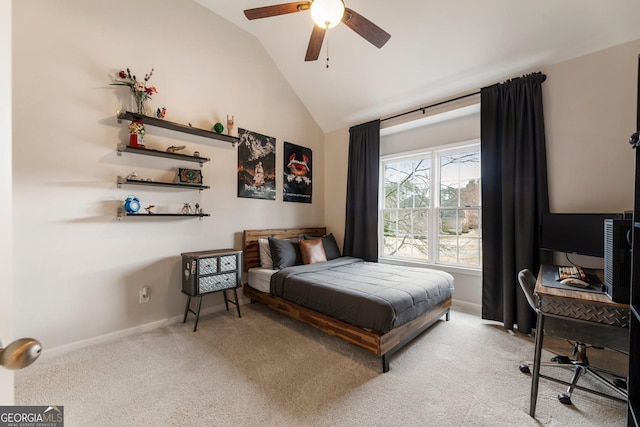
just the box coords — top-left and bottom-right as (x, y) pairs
(0, 1), (13, 405)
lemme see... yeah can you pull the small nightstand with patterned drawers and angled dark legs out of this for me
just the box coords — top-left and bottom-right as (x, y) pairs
(181, 249), (242, 332)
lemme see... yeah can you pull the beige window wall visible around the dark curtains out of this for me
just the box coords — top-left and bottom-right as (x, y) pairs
(325, 40), (640, 304)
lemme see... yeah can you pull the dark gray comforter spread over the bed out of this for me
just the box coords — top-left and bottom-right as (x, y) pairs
(270, 257), (453, 333)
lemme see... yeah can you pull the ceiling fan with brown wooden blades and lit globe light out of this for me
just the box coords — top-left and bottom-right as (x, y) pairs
(244, 0), (391, 61)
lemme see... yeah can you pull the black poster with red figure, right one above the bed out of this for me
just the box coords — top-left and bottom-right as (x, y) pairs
(282, 142), (312, 203)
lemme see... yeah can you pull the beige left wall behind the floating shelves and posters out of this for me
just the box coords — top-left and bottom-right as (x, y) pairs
(12, 0), (324, 354)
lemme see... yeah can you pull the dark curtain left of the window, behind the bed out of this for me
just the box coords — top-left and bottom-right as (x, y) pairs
(342, 120), (380, 262)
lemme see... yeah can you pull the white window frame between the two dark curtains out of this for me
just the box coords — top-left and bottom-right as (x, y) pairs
(378, 139), (482, 272)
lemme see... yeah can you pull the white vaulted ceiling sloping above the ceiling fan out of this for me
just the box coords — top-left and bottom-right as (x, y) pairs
(195, 0), (640, 132)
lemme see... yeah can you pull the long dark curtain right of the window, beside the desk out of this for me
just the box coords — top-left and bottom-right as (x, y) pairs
(480, 73), (549, 334)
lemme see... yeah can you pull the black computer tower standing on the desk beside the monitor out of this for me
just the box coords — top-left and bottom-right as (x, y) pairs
(604, 219), (631, 304)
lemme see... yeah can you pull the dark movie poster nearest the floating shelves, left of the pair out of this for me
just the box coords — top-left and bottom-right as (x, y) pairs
(238, 129), (276, 200)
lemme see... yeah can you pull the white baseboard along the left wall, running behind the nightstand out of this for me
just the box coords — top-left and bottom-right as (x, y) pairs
(40, 304), (232, 358)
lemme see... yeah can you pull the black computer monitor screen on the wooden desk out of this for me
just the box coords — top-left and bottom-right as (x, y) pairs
(540, 213), (622, 258)
